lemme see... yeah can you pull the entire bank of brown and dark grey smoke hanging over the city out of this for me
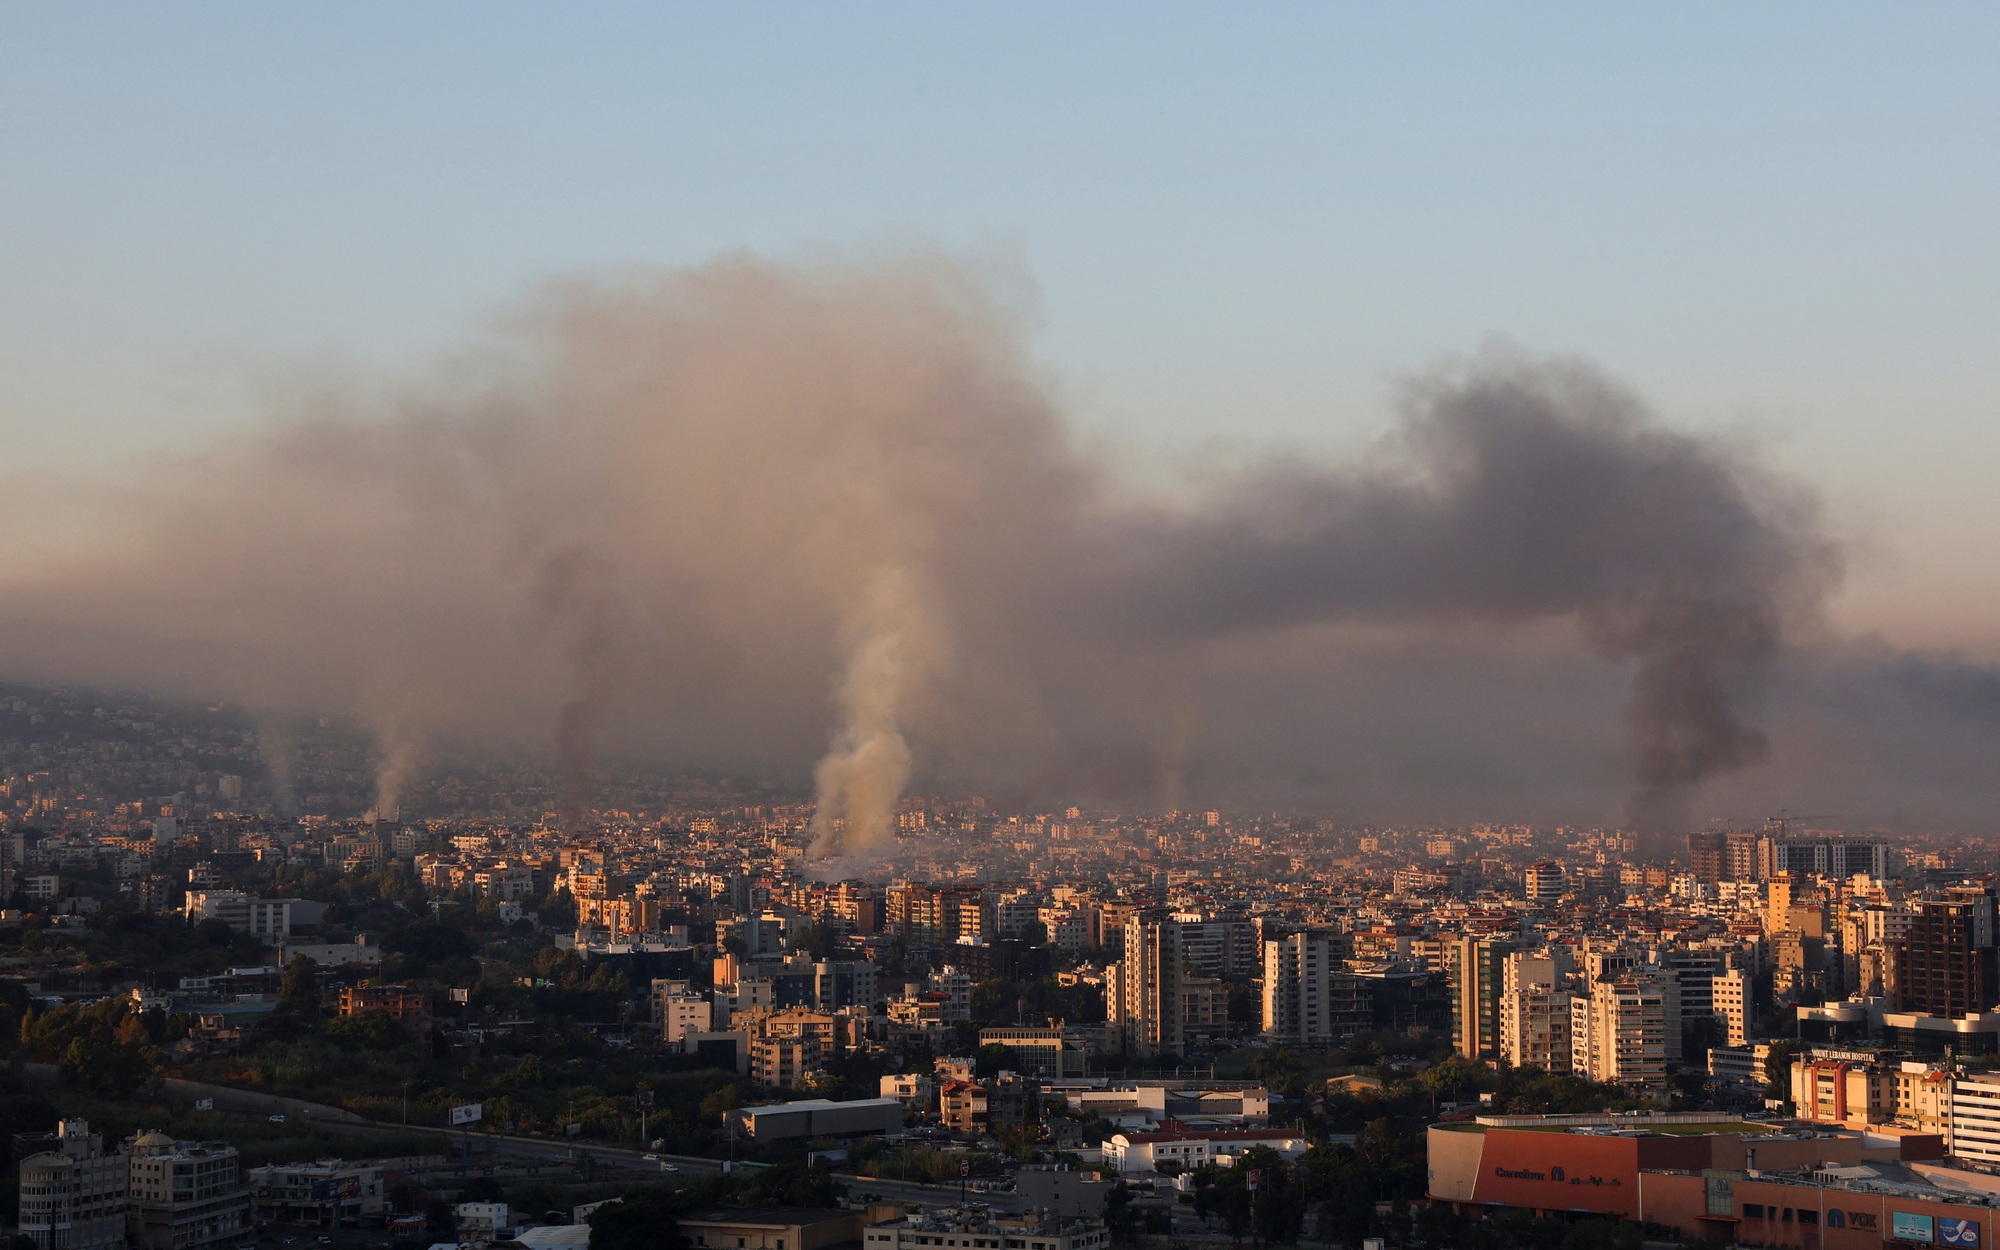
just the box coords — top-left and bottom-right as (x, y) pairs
(0, 246), (1984, 840)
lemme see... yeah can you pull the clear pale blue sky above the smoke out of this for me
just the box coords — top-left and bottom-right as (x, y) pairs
(11, 4), (2000, 650)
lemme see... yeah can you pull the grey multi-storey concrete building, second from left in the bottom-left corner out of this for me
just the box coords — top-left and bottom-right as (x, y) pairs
(126, 1132), (254, 1250)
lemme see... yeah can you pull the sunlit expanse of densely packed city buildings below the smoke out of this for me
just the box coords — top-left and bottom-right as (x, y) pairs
(15, 712), (2000, 1112)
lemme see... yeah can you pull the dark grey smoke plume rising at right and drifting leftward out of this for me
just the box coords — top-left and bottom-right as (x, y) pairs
(1134, 360), (1836, 826)
